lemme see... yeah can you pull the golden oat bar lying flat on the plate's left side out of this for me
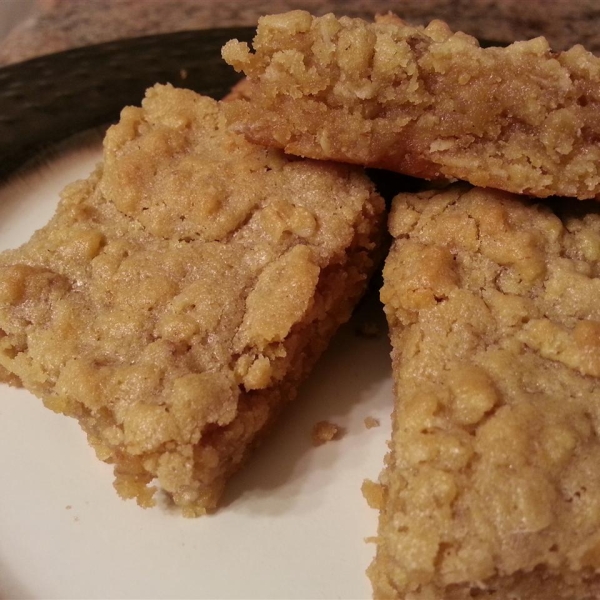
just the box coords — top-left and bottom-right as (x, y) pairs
(0, 86), (383, 516)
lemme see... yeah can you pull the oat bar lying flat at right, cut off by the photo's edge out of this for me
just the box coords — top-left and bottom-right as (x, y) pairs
(370, 188), (600, 600)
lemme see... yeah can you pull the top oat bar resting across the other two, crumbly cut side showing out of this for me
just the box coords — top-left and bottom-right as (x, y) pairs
(223, 11), (600, 199)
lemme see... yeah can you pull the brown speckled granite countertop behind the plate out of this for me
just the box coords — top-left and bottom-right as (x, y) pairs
(0, 0), (600, 65)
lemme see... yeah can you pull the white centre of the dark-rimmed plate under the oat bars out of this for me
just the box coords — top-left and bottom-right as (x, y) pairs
(0, 137), (392, 600)
